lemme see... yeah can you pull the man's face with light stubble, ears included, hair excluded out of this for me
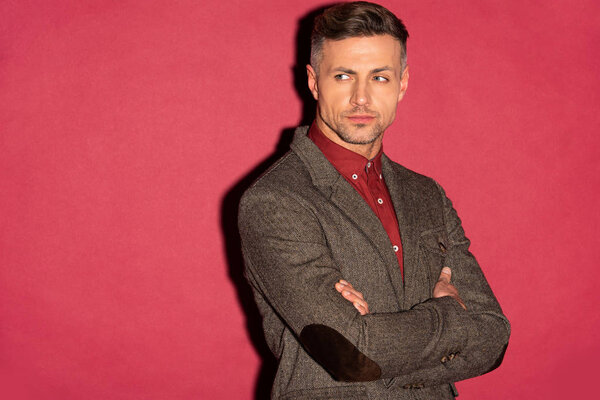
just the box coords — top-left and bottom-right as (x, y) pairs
(307, 35), (408, 155)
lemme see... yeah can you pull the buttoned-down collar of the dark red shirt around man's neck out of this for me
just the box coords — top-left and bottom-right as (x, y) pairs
(308, 122), (383, 179)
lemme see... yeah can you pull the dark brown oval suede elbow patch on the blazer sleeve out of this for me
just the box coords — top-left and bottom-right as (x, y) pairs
(300, 324), (381, 382)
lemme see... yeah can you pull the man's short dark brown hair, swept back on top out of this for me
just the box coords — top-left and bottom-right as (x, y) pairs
(310, 1), (408, 71)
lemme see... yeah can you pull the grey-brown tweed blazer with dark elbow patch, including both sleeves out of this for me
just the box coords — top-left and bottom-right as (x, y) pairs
(239, 127), (510, 399)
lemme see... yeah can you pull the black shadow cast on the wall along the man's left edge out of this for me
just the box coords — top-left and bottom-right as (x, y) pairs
(221, 4), (331, 399)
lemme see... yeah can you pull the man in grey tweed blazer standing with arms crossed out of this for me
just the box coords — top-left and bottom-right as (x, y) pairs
(239, 2), (510, 399)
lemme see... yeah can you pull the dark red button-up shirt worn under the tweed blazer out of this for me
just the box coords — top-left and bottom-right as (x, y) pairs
(308, 123), (404, 279)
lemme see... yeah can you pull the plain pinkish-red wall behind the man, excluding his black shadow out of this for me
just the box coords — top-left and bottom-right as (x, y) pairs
(0, 0), (600, 399)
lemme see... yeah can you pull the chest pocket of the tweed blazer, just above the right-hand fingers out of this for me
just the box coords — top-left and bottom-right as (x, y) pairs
(419, 226), (452, 290)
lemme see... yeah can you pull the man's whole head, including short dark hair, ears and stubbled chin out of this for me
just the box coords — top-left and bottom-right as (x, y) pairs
(307, 2), (408, 158)
